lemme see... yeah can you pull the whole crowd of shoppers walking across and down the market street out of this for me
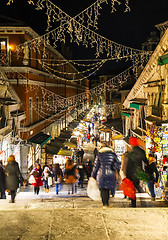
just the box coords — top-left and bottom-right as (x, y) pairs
(0, 109), (168, 208)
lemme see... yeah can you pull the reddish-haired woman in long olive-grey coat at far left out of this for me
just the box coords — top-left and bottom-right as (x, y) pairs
(5, 155), (25, 203)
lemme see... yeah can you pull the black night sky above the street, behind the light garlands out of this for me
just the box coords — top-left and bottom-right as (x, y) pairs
(0, 0), (168, 72)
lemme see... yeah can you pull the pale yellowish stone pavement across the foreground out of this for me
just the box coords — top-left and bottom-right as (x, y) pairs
(0, 192), (168, 240)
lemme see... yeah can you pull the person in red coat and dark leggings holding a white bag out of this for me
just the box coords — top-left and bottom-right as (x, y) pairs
(30, 163), (43, 195)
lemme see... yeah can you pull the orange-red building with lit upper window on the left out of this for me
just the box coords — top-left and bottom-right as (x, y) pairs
(0, 16), (89, 175)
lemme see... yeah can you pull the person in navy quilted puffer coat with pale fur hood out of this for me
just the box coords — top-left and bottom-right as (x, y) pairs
(91, 142), (120, 208)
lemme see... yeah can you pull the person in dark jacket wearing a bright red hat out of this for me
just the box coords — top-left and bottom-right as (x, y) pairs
(126, 137), (148, 207)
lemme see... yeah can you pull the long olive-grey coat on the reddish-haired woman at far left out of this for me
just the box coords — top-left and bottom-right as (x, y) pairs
(5, 161), (24, 191)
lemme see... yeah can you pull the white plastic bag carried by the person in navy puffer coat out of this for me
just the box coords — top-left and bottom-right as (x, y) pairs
(87, 177), (101, 201)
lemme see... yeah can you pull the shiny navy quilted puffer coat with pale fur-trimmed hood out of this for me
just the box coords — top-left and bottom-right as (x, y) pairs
(91, 147), (120, 190)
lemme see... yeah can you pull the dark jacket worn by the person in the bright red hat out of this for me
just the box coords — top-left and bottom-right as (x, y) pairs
(126, 146), (148, 184)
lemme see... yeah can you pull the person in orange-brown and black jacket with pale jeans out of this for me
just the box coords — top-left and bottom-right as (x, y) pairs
(64, 159), (78, 194)
